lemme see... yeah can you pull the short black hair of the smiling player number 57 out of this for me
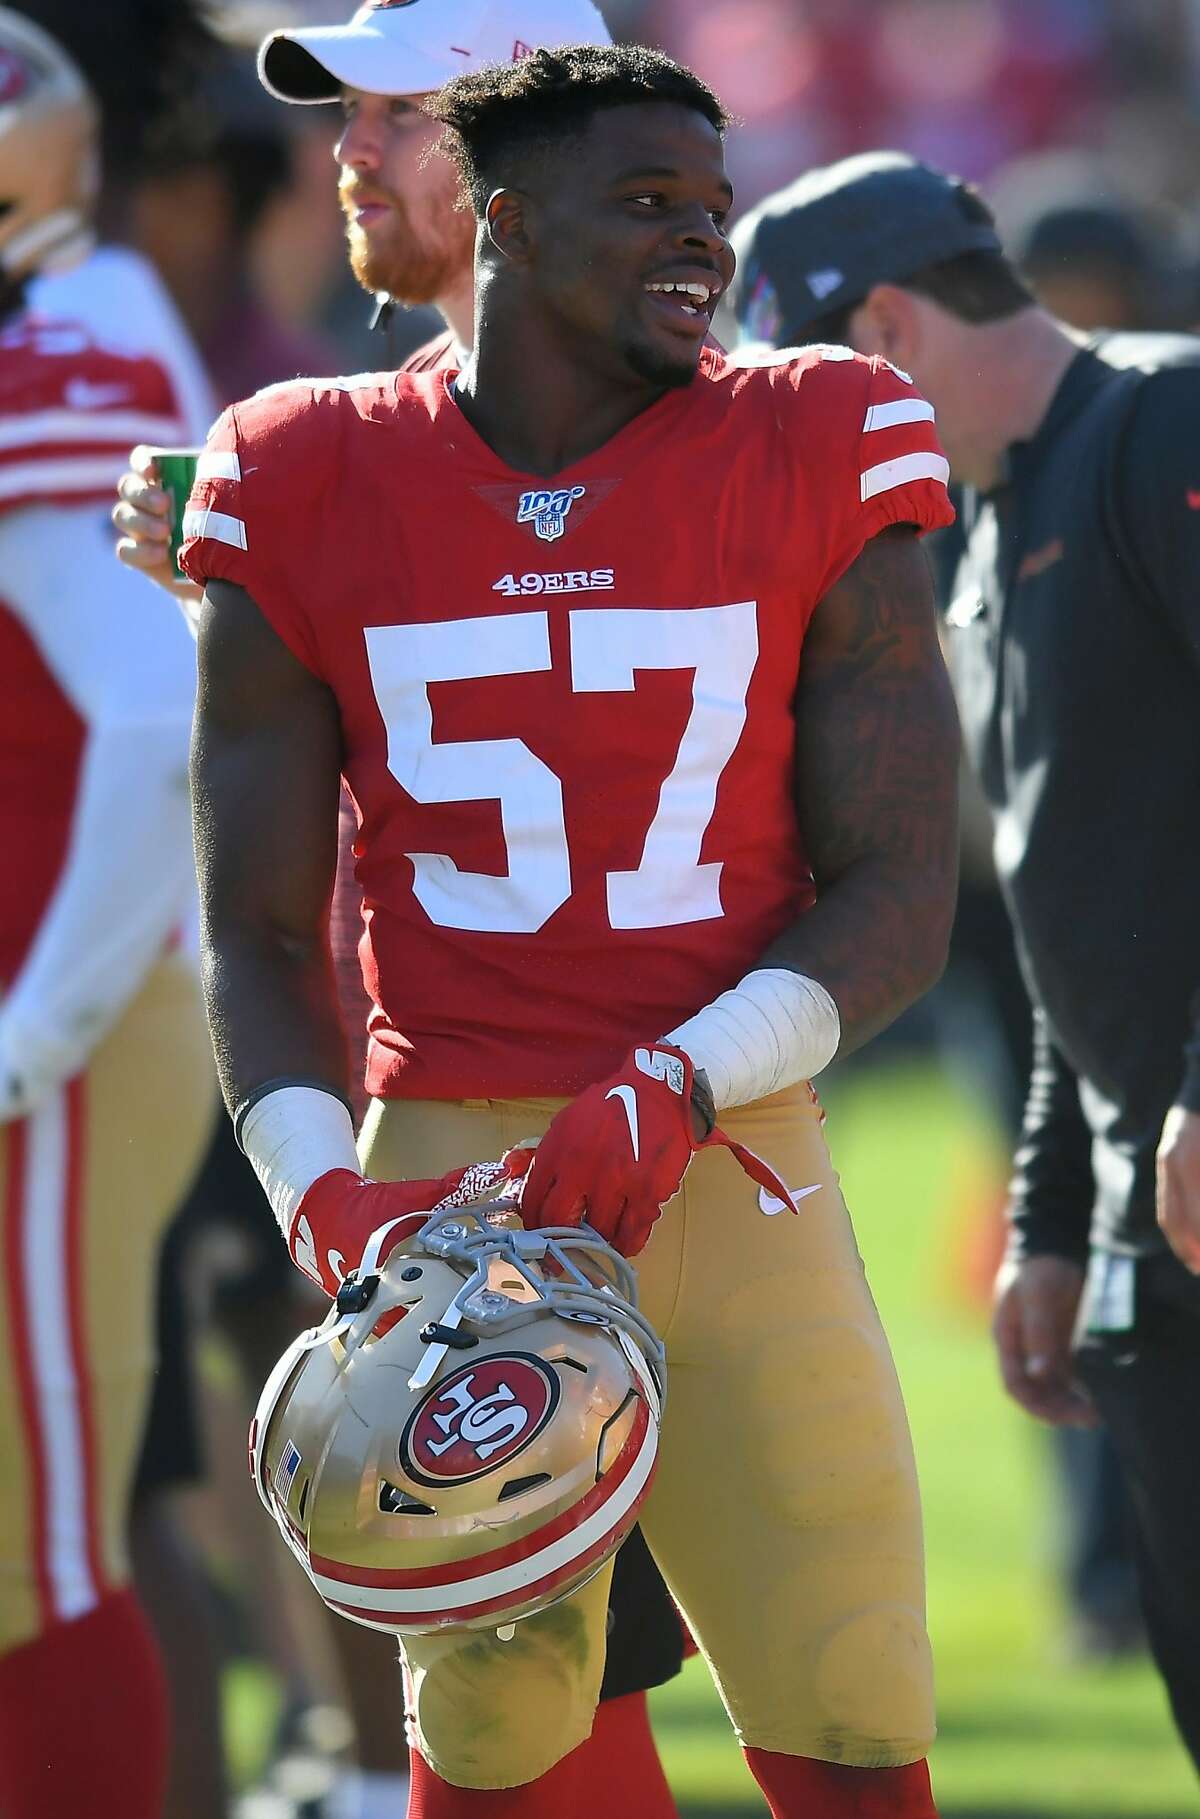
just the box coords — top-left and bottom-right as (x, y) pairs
(425, 44), (729, 215)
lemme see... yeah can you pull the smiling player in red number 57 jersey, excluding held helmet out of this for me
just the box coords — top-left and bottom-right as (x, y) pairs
(184, 47), (958, 1819)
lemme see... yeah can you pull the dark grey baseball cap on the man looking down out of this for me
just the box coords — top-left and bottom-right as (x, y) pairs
(733, 151), (1002, 347)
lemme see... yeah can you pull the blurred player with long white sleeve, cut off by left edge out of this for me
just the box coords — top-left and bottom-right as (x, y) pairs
(0, 7), (215, 1819)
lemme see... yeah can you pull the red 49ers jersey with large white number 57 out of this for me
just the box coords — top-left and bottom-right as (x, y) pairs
(184, 349), (951, 1099)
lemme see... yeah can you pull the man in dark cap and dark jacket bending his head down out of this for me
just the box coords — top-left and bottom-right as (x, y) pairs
(735, 153), (1200, 1764)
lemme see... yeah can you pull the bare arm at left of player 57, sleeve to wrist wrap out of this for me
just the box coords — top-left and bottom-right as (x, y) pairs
(191, 580), (347, 1111)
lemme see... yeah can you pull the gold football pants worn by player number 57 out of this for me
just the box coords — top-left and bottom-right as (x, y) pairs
(360, 1086), (935, 1788)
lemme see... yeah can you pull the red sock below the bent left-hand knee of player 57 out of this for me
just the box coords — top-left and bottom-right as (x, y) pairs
(409, 1693), (676, 1819)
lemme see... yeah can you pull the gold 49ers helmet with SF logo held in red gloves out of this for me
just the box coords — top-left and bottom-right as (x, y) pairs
(251, 1164), (665, 1635)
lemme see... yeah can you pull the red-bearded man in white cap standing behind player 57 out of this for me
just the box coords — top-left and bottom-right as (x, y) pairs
(113, 0), (684, 1819)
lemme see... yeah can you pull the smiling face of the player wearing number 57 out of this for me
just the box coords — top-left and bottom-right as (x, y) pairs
(512, 102), (735, 386)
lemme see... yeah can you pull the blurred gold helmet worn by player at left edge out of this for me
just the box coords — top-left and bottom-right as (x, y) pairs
(0, 5), (100, 282)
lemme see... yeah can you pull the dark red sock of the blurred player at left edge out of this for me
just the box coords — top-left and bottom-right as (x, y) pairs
(0, 1592), (169, 1819)
